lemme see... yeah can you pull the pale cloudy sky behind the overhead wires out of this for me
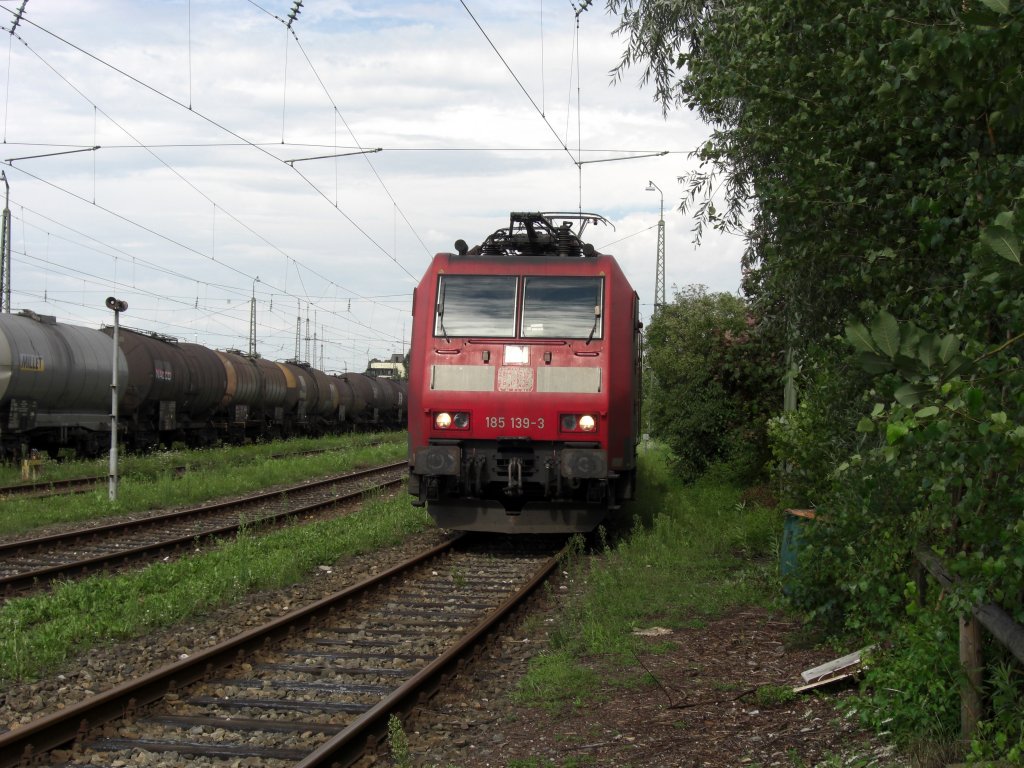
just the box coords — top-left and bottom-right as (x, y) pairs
(0, 0), (742, 371)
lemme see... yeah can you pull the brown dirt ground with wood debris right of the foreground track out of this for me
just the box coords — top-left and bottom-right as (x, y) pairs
(407, 606), (906, 768)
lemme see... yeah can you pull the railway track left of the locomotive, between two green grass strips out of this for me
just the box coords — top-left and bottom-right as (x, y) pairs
(0, 461), (408, 598)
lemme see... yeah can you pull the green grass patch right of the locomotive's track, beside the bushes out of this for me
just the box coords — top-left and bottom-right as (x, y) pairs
(519, 450), (779, 711)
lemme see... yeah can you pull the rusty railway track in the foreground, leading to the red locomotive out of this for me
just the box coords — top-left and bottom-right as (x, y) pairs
(0, 539), (558, 768)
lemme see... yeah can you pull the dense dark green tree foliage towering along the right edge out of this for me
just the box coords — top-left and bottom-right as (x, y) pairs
(608, 0), (1024, 752)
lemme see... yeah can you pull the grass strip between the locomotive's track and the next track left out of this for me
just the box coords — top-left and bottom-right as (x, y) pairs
(0, 495), (432, 682)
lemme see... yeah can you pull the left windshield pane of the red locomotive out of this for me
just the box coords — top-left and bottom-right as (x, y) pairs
(434, 274), (517, 338)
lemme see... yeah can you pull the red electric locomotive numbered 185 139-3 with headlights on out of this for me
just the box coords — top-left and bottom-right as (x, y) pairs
(409, 213), (641, 534)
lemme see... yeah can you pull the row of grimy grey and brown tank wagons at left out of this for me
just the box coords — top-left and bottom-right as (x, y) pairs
(0, 311), (407, 459)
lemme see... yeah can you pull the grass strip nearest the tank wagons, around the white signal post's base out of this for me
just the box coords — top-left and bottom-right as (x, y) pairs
(0, 432), (408, 536)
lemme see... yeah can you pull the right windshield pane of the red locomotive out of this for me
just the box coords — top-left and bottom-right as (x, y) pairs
(522, 275), (604, 339)
